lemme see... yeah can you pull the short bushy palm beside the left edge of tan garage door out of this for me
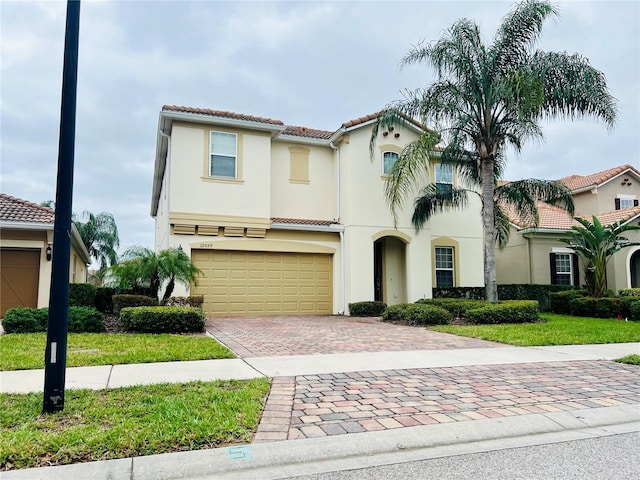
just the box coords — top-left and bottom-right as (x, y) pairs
(112, 246), (202, 300)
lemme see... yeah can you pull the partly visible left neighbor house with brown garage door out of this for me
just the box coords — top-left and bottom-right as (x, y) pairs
(0, 193), (91, 317)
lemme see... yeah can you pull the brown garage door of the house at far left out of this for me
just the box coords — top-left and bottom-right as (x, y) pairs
(0, 248), (40, 317)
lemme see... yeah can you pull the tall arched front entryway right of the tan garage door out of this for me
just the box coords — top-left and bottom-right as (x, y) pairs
(373, 236), (407, 305)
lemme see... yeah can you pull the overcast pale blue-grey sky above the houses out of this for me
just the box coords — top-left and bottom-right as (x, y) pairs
(0, 0), (640, 258)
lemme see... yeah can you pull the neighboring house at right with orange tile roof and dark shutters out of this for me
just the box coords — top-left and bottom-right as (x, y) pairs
(496, 165), (640, 292)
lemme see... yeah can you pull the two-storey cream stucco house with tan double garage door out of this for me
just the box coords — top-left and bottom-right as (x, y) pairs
(151, 106), (483, 315)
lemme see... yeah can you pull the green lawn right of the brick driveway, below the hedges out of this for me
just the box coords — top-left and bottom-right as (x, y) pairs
(429, 313), (640, 346)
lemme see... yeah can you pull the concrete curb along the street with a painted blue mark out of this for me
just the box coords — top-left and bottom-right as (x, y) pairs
(2, 405), (640, 480)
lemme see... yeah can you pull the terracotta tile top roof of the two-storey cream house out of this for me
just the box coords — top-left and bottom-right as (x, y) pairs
(162, 105), (425, 140)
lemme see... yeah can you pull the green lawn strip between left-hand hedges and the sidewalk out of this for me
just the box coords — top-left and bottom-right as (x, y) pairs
(0, 333), (234, 370)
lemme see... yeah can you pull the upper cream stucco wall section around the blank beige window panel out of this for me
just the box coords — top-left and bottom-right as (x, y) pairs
(271, 141), (337, 220)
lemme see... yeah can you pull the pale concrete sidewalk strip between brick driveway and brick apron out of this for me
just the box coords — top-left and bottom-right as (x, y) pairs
(0, 342), (640, 393)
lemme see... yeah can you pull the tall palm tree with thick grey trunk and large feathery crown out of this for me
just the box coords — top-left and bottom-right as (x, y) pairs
(372, 0), (617, 302)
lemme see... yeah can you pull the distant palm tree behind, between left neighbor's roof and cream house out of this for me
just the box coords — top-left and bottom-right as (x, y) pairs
(73, 211), (120, 270)
